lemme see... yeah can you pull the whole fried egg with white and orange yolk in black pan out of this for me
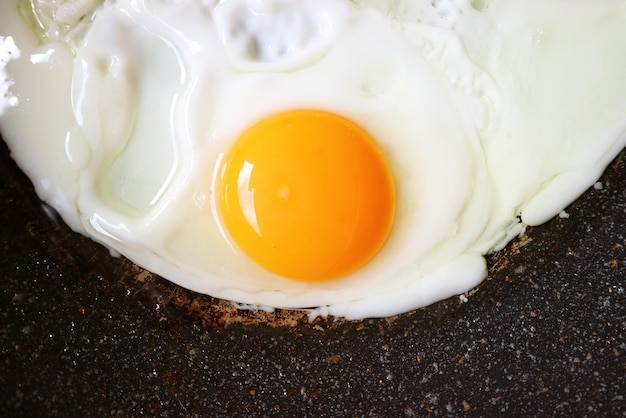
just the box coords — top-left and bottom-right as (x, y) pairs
(0, 0), (626, 319)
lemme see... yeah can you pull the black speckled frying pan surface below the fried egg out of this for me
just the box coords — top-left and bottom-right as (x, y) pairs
(0, 131), (626, 417)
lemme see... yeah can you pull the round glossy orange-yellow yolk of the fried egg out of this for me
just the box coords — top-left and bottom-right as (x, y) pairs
(218, 110), (395, 281)
